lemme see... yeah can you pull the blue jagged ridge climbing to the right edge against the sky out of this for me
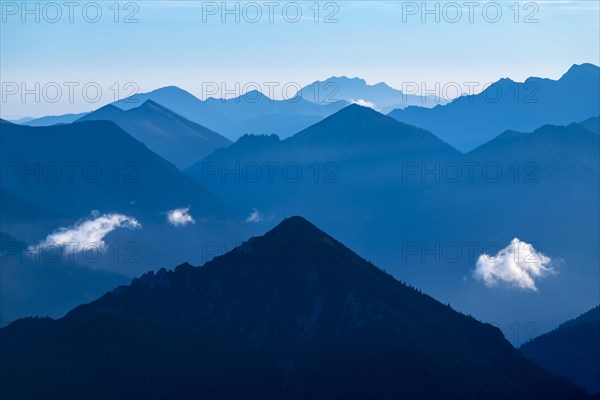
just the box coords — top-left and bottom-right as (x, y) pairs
(389, 64), (600, 151)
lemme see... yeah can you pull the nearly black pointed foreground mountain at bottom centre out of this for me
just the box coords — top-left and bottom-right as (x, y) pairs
(0, 217), (584, 400)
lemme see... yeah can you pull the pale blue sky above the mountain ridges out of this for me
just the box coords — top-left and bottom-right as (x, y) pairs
(0, 1), (600, 119)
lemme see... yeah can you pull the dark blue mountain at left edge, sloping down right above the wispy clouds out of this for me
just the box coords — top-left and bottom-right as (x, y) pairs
(0, 121), (227, 218)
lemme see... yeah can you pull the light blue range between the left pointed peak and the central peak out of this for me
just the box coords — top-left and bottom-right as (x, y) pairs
(113, 86), (348, 140)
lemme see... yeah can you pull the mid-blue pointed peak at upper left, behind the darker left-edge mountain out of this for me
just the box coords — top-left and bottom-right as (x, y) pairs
(77, 100), (231, 169)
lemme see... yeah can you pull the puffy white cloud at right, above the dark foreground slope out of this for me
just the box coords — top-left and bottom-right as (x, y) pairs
(473, 238), (555, 291)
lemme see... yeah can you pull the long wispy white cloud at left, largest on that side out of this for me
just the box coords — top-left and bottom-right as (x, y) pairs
(29, 210), (141, 253)
